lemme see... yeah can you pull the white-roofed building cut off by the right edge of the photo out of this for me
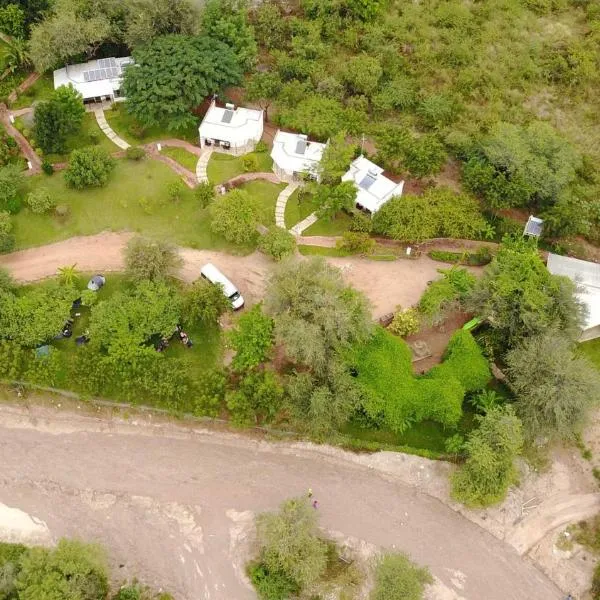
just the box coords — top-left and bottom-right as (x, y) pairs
(547, 253), (600, 342)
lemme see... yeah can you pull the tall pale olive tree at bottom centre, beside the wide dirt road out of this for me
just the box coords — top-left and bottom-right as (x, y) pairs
(256, 498), (327, 588)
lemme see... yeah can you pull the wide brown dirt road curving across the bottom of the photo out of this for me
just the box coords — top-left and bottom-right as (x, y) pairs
(0, 405), (561, 600)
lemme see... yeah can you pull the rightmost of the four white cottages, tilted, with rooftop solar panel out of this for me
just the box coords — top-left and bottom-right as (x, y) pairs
(342, 156), (404, 214)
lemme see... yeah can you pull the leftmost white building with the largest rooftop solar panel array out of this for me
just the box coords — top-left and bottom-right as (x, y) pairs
(54, 56), (133, 102)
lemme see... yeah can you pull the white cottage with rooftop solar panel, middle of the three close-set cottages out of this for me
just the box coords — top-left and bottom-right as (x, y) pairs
(271, 130), (327, 182)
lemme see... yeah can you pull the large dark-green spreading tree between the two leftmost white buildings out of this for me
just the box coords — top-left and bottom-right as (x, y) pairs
(122, 35), (241, 129)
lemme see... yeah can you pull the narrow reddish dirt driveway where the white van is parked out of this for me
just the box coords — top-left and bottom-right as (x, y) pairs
(0, 233), (444, 318)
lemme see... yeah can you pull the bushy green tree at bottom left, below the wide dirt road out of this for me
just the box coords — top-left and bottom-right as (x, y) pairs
(17, 539), (109, 600)
